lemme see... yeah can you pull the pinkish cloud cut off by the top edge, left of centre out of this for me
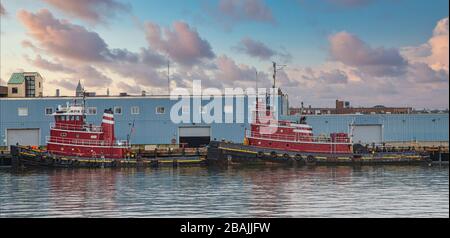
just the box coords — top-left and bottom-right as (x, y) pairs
(42, 0), (131, 23)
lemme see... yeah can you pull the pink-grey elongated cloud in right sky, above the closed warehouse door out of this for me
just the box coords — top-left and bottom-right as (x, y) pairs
(329, 31), (408, 77)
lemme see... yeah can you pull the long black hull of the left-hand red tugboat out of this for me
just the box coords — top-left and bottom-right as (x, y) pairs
(11, 146), (204, 168)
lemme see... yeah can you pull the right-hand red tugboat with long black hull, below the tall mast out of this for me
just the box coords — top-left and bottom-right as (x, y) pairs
(207, 97), (429, 165)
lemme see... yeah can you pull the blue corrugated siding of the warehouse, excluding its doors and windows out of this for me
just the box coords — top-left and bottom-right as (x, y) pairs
(0, 98), (449, 145)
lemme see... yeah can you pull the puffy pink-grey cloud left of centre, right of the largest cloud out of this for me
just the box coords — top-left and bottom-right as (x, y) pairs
(145, 21), (215, 66)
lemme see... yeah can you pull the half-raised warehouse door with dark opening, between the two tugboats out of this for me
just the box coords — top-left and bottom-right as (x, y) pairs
(179, 127), (211, 148)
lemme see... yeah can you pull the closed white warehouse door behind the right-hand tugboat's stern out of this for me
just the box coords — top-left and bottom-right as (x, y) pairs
(353, 125), (383, 144)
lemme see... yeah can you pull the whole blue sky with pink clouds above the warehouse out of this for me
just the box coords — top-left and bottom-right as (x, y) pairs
(0, 0), (449, 109)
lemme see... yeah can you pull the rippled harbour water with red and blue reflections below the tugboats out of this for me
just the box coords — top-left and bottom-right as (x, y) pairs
(0, 166), (449, 217)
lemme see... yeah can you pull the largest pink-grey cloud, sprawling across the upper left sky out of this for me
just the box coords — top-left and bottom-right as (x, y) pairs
(18, 9), (172, 89)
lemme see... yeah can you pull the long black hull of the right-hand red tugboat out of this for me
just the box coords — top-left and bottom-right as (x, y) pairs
(207, 141), (432, 165)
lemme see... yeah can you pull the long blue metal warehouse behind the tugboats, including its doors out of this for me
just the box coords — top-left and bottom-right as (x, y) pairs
(0, 96), (449, 146)
